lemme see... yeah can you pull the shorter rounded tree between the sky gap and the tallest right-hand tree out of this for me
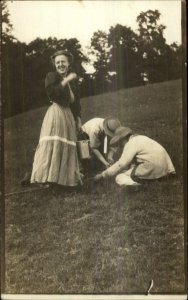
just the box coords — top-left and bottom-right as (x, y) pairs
(91, 24), (141, 92)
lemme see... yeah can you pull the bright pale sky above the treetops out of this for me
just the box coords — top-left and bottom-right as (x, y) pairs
(8, 0), (181, 48)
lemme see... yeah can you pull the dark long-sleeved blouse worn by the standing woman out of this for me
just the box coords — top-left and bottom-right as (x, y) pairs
(45, 72), (81, 119)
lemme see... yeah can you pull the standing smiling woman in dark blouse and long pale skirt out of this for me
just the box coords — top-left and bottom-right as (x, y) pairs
(31, 50), (81, 186)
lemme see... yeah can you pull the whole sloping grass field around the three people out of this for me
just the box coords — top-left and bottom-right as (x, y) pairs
(5, 80), (185, 294)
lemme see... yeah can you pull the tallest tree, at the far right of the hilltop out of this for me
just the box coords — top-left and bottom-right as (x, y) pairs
(137, 10), (181, 82)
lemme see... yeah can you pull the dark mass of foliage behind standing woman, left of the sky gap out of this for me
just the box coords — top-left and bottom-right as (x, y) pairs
(2, 38), (87, 117)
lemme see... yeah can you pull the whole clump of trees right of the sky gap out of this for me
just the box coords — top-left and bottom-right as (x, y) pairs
(91, 10), (182, 90)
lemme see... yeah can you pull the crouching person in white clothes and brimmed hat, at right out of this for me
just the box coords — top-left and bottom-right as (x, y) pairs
(94, 127), (175, 186)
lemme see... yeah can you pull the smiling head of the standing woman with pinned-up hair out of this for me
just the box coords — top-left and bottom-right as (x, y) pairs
(51, 50), (73, 76)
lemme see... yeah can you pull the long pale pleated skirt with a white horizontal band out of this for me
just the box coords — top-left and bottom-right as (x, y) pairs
(31, 103), (81, 186)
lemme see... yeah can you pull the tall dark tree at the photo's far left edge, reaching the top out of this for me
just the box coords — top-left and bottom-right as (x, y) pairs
(1, 0), (25, 117)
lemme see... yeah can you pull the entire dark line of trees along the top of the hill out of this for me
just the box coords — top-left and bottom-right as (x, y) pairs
(1, 1), (182, 117)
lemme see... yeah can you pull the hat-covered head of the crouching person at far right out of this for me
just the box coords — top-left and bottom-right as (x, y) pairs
(110, 126), (133, 147)
